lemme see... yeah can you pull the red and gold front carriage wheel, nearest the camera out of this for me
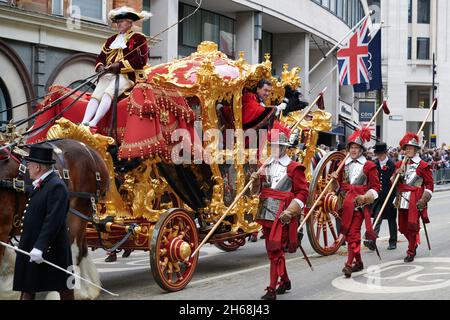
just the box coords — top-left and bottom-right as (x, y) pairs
(150, 208), (198, 292)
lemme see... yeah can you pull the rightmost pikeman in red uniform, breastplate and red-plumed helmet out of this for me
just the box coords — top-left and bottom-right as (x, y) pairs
(395, 133), (434, 262)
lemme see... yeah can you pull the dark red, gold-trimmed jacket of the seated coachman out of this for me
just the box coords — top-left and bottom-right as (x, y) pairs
(95, 30), (148, 82)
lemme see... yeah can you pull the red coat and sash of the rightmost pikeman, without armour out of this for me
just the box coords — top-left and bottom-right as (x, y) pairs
(395, 160), (434, 233)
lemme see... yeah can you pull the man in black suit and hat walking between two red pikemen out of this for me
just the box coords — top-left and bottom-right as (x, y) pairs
(364, 142), (397, 250)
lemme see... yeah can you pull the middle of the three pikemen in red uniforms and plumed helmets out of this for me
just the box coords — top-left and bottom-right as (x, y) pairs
(332, 129), (381, 278)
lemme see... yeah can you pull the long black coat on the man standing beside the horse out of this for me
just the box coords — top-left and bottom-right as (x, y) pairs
(13, 172), (72, 293)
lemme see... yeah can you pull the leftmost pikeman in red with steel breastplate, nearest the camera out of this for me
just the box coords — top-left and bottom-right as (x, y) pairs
(252, 130), (308, 300)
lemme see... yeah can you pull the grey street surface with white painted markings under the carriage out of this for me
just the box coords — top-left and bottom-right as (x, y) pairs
(96, 187), (450, 300)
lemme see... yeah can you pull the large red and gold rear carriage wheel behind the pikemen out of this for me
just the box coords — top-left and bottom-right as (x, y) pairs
(306, 151), (345, 256)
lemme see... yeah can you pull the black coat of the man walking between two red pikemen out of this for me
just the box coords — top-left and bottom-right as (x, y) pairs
(372, 158), (397, 219)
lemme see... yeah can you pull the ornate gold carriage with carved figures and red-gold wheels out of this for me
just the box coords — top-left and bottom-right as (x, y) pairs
(47, 42), (340, 291)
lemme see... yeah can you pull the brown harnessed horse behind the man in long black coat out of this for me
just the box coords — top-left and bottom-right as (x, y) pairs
(0, 139), (109, 299)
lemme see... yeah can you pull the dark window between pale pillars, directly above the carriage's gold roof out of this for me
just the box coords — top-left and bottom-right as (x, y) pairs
(178, 3), (236, 58)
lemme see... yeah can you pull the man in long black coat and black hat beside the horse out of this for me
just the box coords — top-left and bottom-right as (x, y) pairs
(13, 145), (74, 300)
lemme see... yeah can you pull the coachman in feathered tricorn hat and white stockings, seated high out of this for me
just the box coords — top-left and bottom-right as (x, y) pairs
(82, 7), (151, 128)
